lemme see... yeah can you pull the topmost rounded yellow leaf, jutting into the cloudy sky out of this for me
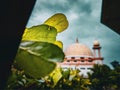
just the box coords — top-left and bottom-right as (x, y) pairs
(44, 13), (69, 33)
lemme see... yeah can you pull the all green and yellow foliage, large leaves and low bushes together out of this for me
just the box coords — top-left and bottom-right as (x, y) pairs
(6, 13), (120, 90)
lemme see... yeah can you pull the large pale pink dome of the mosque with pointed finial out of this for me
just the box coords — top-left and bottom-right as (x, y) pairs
(65, 41), (93, 57)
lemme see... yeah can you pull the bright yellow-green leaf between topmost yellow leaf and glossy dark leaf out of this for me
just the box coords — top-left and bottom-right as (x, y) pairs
(22, 24), (57, 43)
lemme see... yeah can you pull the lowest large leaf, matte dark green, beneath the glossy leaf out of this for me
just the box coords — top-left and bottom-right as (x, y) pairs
(14, 49), (56, 79)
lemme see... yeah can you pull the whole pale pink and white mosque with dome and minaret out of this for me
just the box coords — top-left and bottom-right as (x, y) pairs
(59, 39), (103, 77)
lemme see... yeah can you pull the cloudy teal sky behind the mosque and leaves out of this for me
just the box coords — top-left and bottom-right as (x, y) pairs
(26, 0), (120, 65)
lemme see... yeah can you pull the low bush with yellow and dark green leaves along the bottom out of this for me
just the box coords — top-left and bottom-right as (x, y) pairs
(7, 68), (91, 90)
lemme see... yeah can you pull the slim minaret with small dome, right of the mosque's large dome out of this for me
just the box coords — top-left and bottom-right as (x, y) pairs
(93, 40), (103, 64)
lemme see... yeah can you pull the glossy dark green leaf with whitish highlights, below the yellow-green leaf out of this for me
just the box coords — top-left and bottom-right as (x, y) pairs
(20, 41), (65, 62)
